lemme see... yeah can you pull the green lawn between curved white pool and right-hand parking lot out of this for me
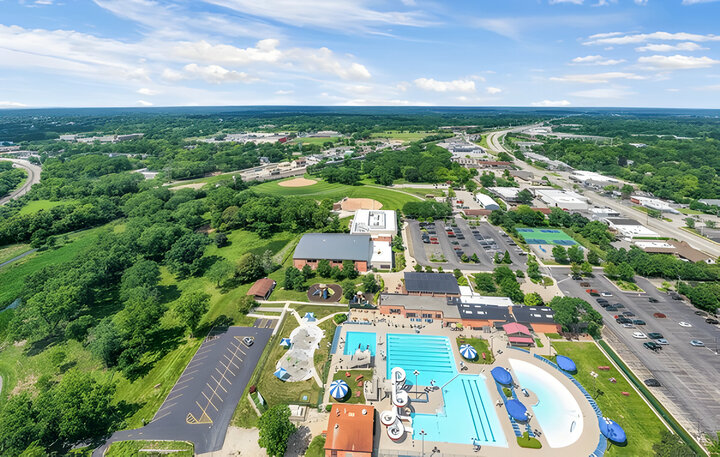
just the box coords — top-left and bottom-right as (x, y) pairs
(552, 341), (665, 457)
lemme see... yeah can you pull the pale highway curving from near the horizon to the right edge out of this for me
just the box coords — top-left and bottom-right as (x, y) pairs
(480, 124), (720, 257)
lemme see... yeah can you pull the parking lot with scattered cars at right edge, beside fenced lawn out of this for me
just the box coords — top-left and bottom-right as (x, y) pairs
(553, 268), (720, 433)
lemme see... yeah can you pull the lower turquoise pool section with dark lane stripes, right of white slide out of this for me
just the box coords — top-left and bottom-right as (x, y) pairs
(411, 374), (508, 447)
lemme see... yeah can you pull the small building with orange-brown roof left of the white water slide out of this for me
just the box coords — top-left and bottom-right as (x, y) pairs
(325, 404), (375, 457)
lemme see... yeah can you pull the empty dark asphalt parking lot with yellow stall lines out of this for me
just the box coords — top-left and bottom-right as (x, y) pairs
(93, 322), (273, 457)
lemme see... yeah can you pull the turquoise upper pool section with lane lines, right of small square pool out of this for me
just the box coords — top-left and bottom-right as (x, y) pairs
(388, 333), (457, 386)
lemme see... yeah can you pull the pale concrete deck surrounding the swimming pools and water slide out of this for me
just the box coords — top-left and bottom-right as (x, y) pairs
(324, 310), (600, 457)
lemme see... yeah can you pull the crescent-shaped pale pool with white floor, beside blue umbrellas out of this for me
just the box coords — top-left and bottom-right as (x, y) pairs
(510, 359), (583, 448)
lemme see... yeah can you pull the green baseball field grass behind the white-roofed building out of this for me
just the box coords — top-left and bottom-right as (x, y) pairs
(253, 178), (418, 210)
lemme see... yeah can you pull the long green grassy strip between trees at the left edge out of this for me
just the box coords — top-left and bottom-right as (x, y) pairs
(0, 224), (112, 309)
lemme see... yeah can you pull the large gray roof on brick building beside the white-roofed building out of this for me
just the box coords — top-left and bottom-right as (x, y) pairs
(293, 233), (372, 262)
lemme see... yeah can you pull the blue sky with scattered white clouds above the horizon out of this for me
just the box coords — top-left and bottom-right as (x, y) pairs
(0, 0), (720, 108)
